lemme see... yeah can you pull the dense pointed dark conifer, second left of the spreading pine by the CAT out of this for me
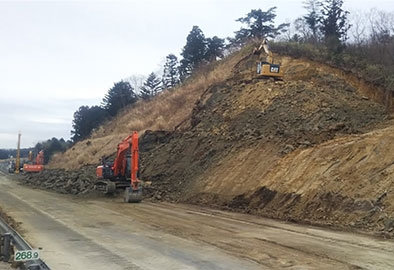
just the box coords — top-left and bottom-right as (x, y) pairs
(180, 26), (207, 78)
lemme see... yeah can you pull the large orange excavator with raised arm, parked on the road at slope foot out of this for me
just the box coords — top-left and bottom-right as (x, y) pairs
(95, 131), (142, 202)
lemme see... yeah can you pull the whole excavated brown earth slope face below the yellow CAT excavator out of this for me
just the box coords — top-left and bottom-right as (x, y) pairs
(142, 54), (394, 234)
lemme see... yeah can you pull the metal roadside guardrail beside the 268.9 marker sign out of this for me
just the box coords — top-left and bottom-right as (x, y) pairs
(0, 217), (50, 270)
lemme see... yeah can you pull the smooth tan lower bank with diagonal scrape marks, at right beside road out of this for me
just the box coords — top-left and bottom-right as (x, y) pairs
(188, 123), (394, 232)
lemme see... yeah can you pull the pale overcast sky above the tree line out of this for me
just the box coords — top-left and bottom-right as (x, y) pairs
(0, 0), (394, 148)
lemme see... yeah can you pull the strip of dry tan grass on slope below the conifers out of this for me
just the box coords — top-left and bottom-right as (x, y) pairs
(48, 44), (254, 169)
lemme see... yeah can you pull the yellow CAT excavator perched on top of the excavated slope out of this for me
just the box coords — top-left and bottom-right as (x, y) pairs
(253, 38), (283, 80)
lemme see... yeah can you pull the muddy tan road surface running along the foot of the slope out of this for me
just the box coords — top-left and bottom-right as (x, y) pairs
(0, 173), (394, 269)
